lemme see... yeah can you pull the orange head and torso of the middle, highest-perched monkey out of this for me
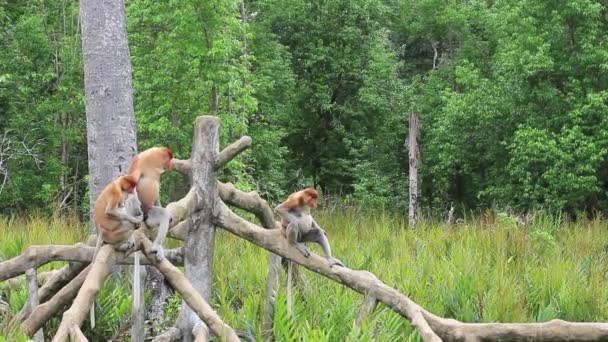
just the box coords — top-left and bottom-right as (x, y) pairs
(128, 147), (173, 214)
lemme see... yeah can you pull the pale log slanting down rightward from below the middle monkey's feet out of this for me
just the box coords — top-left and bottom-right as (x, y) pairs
(135, 232), (239, 341)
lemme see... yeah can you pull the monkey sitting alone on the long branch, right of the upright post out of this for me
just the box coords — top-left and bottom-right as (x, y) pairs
(274, 188), (344, 267)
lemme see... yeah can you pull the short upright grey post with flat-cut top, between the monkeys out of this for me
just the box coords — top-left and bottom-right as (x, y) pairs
(177, 116), (220, 341)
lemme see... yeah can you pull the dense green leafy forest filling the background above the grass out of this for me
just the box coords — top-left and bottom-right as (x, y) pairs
(0, 0), (608, 213)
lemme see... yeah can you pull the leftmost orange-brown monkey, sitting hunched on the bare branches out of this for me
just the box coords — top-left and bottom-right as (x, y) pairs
(95, 176), (142, 245)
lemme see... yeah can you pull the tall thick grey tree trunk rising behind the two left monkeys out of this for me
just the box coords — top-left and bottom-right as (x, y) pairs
(80, 0), (137, 232)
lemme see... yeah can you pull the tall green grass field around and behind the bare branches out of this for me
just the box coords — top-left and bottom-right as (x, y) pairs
(0, 211), (608, 341)
